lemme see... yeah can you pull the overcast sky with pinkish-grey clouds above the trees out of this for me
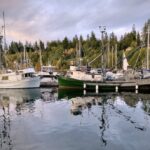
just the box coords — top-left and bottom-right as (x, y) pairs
(0, 0), (150, 42)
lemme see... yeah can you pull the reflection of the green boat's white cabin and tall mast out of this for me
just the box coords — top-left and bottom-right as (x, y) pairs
(70, 97), (109, 146)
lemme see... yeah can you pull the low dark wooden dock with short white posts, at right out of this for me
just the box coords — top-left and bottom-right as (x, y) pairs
(83, 78), (150, 94)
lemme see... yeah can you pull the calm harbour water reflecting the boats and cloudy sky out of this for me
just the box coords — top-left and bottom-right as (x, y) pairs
(0, 89), (150, 150)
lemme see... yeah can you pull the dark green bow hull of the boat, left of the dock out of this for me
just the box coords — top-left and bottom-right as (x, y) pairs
(58, 76), (83, 89)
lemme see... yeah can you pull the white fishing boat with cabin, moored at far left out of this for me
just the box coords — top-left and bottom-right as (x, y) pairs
(0, 22), (40, 89)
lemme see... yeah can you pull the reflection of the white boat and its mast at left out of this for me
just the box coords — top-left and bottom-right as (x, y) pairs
(0, 88), (57, 150)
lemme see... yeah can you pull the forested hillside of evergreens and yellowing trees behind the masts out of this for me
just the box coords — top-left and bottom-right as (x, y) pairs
(4, 19), (150, 71)
